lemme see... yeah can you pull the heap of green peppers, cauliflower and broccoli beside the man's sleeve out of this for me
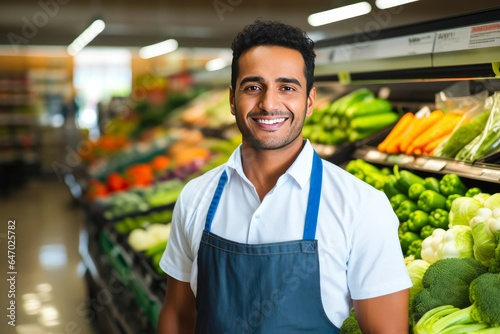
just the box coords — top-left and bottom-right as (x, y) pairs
(341, 159), (500, 334)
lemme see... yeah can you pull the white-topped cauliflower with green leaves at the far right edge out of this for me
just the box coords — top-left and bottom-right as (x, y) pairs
(470, 208), (500, 267)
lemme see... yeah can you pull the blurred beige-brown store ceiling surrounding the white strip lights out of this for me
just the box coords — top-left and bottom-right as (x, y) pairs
(0, 0), (499, 50)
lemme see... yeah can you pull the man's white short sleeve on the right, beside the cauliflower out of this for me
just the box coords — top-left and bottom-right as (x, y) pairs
(347, 191), (412, 299)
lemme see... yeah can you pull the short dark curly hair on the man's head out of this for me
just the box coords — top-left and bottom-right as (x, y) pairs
(231, 19), (316, 95)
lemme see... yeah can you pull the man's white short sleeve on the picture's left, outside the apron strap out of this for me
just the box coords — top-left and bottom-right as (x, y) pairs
(160, 191), (194, 282)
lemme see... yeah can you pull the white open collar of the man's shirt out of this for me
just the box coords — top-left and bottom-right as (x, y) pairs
(226, 139), (314, 188)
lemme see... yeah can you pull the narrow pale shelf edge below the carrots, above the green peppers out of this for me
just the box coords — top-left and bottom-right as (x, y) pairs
(353, 147), (500, 183)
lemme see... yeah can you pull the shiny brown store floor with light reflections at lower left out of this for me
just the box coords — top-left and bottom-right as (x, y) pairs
(0, 178), (101, 334)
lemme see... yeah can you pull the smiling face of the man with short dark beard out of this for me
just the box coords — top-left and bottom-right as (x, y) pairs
(230, 46), (316, 150)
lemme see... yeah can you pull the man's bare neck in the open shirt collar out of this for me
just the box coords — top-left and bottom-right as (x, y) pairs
(241, 140), (305, 202)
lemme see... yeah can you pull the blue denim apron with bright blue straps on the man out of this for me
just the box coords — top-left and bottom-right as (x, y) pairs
(196, 153), (339, 334)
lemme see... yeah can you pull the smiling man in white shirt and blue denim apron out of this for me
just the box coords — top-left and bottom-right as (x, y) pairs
(158, 21), (411, 334)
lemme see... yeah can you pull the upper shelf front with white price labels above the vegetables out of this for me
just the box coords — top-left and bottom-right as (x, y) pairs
(316, 7), (500, 83)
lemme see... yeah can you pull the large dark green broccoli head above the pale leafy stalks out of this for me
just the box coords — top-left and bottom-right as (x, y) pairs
(413, 258), (488, 323)
